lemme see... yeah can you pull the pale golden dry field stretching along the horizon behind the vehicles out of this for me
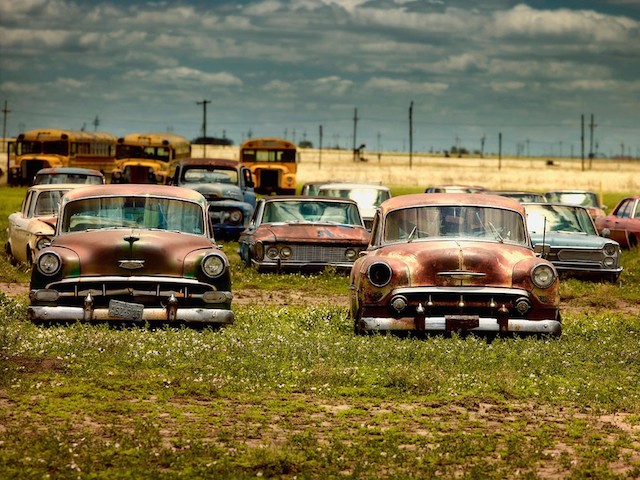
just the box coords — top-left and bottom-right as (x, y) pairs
(193, 145), (640, 194)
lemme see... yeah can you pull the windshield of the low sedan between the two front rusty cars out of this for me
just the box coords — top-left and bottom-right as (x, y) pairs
(262, 200), (362, 226)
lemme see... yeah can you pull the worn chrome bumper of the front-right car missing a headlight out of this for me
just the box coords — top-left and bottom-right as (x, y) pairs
(360, 317), (562, 336)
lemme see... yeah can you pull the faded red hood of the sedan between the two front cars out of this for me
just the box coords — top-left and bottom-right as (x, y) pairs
(257, 223), (369, 244)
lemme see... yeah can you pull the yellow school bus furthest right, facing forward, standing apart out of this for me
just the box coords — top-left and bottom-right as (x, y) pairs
(240, 138), (298, 195)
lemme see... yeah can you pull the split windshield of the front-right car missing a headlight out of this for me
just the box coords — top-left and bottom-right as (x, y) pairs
(384, 205), (527, 245)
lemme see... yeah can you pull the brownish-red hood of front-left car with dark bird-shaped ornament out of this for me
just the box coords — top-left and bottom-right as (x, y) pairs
(51, 229), (214, 277)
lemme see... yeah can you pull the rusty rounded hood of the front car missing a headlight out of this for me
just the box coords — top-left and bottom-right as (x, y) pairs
(363, 240), (538, 287)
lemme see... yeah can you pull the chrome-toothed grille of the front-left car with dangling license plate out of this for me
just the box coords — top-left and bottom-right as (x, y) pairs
(48, 277), (215, 307)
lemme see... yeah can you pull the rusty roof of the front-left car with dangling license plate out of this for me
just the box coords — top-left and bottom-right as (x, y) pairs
(61, 183), (204, 202)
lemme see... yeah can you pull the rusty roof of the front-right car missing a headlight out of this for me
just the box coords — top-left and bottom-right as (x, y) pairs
(380, 193), (525, 214)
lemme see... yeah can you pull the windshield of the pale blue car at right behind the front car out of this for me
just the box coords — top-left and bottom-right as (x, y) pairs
(525, 205), (598, 235)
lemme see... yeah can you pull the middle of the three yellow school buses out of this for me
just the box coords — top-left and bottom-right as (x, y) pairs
(111, 132), (191, 184)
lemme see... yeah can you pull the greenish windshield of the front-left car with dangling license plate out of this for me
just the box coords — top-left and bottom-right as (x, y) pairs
(61, 196), (204, 234)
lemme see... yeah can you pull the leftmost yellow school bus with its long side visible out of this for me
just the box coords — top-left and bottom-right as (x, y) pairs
(9, 129), (116, 185)
